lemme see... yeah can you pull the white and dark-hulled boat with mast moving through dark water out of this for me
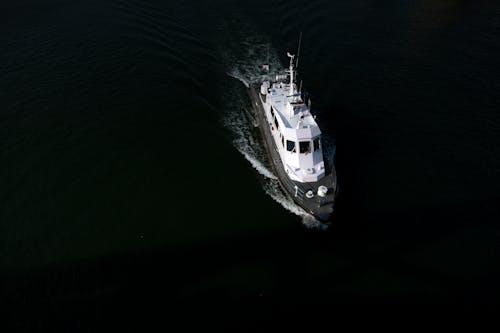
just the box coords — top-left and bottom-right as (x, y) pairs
(247, 42), (338, 223)
